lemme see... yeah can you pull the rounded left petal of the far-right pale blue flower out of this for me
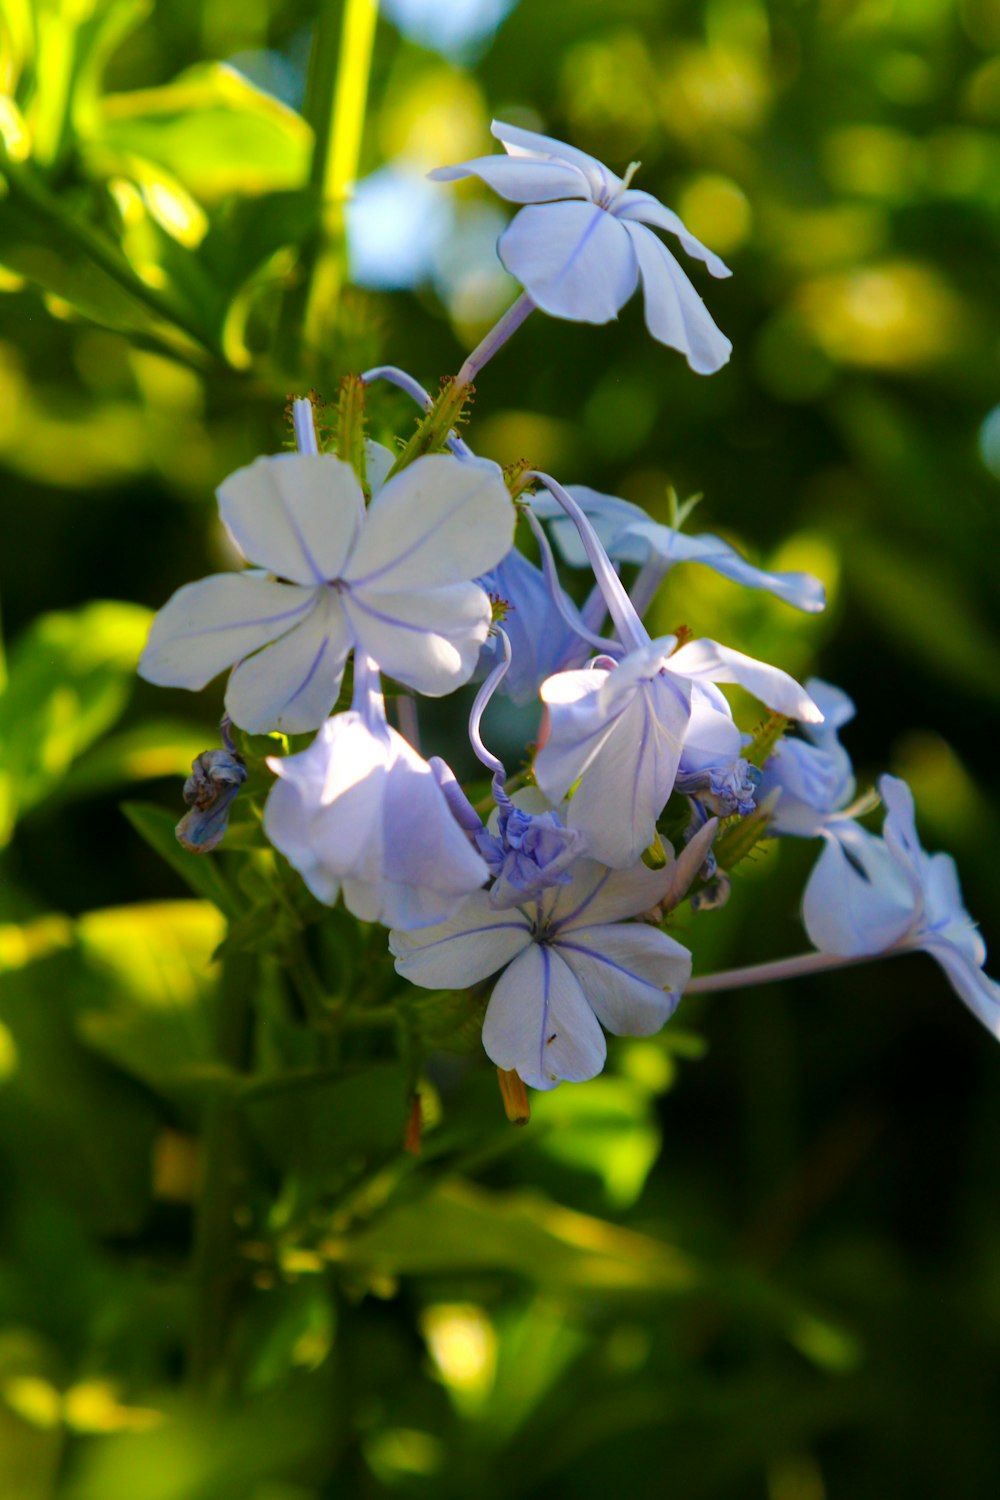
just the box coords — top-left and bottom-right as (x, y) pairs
(802, 821), (916, 957)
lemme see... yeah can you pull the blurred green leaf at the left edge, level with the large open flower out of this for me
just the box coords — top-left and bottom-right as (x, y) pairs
(0, 603), (151, 843)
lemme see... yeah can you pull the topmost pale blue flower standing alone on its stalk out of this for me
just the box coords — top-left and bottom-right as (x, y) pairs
(430, 120), (732, 375)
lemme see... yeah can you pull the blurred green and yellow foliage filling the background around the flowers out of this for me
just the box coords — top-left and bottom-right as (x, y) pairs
(0, 0), (1000, 1500)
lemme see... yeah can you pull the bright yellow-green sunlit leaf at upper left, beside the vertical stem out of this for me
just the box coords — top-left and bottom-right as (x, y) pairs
(93, 63), (312, 203)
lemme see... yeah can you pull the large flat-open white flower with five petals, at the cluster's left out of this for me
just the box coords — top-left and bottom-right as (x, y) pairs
(139, 446), (514, 734)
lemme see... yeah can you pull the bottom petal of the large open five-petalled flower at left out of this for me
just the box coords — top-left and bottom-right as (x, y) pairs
(226, 588), (351, 735)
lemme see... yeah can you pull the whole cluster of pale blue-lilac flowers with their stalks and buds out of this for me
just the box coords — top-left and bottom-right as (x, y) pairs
(139, 125), (1000, 1110)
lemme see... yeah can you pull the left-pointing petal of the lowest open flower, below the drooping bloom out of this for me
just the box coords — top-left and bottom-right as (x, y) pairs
(388, 891), (532, 990)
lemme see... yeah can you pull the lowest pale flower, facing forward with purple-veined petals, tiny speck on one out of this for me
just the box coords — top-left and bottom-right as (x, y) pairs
(388, 822), (717, 1089)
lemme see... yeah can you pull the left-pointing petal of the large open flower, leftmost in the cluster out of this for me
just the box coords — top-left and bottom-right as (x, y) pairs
(139, 573), (316, 689)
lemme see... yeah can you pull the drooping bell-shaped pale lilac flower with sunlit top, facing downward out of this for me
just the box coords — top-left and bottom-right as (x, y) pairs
(264, 710), (489, 929)
